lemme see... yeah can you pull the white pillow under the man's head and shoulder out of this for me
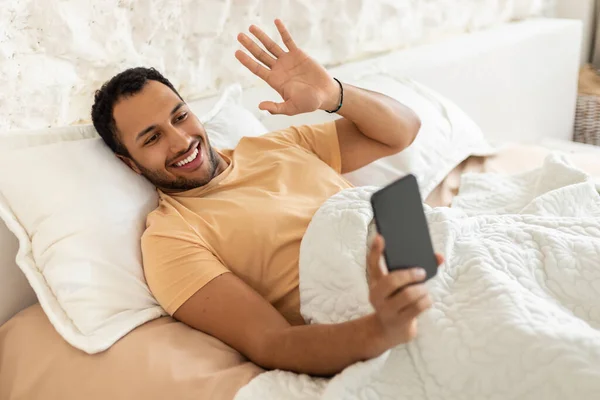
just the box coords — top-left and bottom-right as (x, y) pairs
(0, 86), (266, 353)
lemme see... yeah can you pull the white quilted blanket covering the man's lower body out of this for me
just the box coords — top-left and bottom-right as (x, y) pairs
(236, 155), (600, 400)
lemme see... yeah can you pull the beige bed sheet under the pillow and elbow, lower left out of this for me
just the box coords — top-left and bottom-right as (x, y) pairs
(0, 304), (263, 400)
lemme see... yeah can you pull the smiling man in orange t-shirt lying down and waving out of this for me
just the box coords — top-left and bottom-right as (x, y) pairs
(92, 20), (441, 375)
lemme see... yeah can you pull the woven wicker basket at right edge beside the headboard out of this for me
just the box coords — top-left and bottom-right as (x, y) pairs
(573, 94), (600, 146)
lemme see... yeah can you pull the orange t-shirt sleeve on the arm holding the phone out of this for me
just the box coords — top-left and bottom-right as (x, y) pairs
(142, 216), (229, 315)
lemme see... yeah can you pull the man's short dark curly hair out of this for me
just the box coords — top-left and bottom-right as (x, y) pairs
(92, 67), (183, 157)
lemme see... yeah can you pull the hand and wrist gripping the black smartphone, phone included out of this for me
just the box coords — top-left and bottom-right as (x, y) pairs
(367, 175), (444, 348)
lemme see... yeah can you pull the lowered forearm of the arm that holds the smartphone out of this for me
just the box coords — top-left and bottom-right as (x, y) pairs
(255, 315), (387, 376)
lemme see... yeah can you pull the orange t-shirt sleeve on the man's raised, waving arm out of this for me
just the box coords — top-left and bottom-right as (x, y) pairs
(267, 121), (342, 173)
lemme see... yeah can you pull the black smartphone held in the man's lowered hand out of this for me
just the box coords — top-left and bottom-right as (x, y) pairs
(371, 174), (438, 280)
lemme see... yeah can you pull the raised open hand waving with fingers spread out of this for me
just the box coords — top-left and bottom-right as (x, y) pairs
(235, 19), (339, 115)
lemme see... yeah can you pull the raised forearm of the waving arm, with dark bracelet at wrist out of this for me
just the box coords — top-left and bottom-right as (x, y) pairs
(324, 82), (421, 150)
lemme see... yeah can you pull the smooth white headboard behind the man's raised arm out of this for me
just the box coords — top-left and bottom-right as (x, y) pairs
(239, 19), (581, 142)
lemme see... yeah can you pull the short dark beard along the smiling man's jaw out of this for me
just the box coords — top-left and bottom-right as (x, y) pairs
(132, 143), (219, 192)
